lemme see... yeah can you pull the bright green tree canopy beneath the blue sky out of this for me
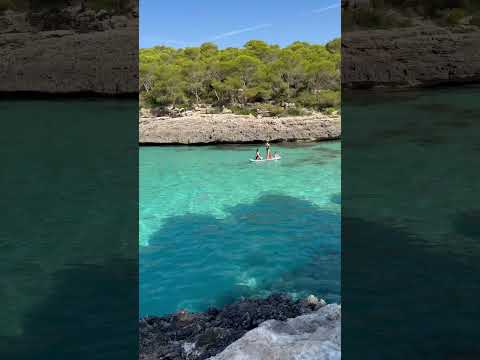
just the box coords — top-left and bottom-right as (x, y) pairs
(139, 39), (340, 115)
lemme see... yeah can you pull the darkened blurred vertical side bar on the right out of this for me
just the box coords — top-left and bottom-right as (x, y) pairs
(342, 0), (480, 360)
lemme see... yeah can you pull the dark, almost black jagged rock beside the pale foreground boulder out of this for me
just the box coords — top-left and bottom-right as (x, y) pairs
(139, 295), (325, 360)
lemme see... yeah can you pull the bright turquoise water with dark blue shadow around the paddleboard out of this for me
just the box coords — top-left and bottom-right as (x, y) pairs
(139, 142), (341, 316)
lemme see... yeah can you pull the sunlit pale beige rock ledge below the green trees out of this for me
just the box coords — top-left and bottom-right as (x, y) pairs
(140, 113), (341, 144)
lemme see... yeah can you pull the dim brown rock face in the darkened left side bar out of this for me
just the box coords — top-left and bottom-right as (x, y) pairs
(0, 9), (138, 95)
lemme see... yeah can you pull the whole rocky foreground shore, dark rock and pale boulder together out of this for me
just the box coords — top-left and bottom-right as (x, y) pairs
(139, 294), (341, 360)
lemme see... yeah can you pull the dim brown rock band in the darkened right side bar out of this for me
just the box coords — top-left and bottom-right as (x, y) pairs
(342, 25), (480, 88)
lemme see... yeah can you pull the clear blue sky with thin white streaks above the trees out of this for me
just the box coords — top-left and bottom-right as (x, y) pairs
(140, 0), (341, 48)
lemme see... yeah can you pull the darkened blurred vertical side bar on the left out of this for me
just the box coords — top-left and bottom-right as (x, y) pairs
(0, 0), (138, 360)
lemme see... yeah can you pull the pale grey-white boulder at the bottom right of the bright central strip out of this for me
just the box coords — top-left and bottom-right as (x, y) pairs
(209, 304), (341, 360)
